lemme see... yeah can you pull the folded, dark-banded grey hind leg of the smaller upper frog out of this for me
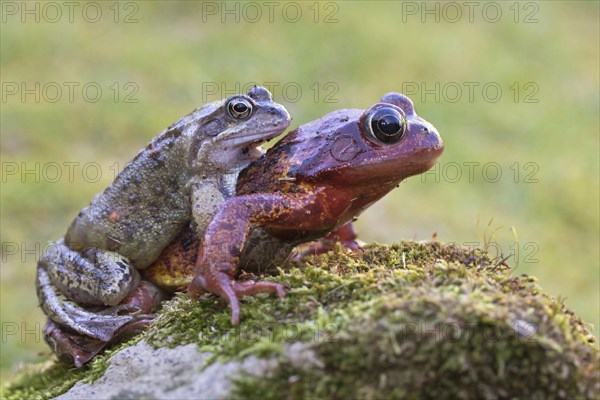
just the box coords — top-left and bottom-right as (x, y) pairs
(36, 239), (151, 341)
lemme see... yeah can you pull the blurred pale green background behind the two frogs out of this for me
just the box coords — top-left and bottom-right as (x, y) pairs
(0, 1), (600, 378)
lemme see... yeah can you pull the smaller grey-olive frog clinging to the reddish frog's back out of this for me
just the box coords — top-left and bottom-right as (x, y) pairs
(36, 86), (290, 366)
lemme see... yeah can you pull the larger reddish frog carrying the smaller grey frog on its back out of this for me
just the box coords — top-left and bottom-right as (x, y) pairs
(146, 93), (443, 324)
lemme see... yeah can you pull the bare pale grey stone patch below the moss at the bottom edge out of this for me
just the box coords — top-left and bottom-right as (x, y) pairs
(56, 341), (276, 400)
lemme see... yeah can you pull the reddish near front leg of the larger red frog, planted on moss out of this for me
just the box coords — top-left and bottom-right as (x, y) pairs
(188, 194), (307, 325)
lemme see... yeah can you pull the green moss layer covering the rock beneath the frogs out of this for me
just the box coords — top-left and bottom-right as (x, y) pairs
(3, 242), (600, 399)
